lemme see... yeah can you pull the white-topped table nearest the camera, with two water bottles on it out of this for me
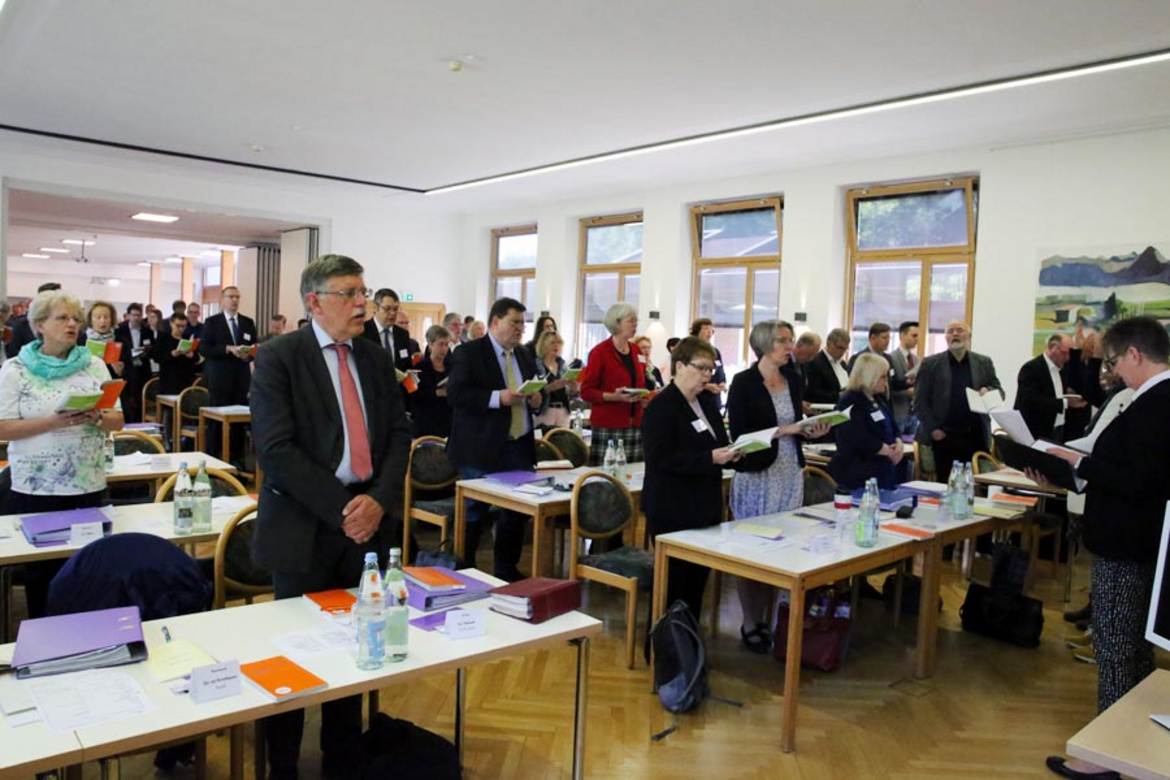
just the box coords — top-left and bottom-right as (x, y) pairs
(0, 573), (603, 778)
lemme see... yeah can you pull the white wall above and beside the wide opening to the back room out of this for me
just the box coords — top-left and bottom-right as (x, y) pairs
(0, 132), (472, 313)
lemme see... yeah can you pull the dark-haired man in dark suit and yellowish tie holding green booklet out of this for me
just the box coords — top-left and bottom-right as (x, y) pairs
(447, 298), (541, 581)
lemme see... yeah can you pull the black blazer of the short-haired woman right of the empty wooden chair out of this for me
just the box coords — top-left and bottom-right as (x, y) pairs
(642, 382), (728, 534)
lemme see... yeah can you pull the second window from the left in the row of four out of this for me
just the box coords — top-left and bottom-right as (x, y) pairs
(577, 213), (642, 358)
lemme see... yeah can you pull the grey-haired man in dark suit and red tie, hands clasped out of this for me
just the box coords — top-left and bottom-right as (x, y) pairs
(251, 255), (411, 780)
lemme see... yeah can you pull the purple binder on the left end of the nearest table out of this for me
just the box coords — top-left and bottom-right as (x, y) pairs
(12, 607), (146, 677)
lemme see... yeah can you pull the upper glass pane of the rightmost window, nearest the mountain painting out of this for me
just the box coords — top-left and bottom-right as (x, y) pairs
(858, 189), (966, 249)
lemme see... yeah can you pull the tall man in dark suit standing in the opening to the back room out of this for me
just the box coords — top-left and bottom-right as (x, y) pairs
(199, 287), (256, 461)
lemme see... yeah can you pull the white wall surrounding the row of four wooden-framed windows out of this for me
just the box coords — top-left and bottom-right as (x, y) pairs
(453, 129), (1170, 398)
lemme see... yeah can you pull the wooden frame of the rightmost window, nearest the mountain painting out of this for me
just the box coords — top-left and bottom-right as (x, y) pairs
(844, 175), (979, 358)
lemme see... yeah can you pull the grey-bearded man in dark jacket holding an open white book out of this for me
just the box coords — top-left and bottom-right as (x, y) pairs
(914, 320), (1004, 482)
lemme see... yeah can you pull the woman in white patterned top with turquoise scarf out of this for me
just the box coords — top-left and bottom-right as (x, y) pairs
(0, 290), (122, 617)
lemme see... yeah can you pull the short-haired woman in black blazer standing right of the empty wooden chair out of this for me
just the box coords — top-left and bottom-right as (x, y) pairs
(642, 337), (739, 617)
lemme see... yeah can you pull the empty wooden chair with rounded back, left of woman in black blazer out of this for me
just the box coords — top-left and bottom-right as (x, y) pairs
(569, 471), (654, 669)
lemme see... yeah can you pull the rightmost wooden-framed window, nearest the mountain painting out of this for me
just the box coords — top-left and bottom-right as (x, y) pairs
(846, 179), (979, 354)
